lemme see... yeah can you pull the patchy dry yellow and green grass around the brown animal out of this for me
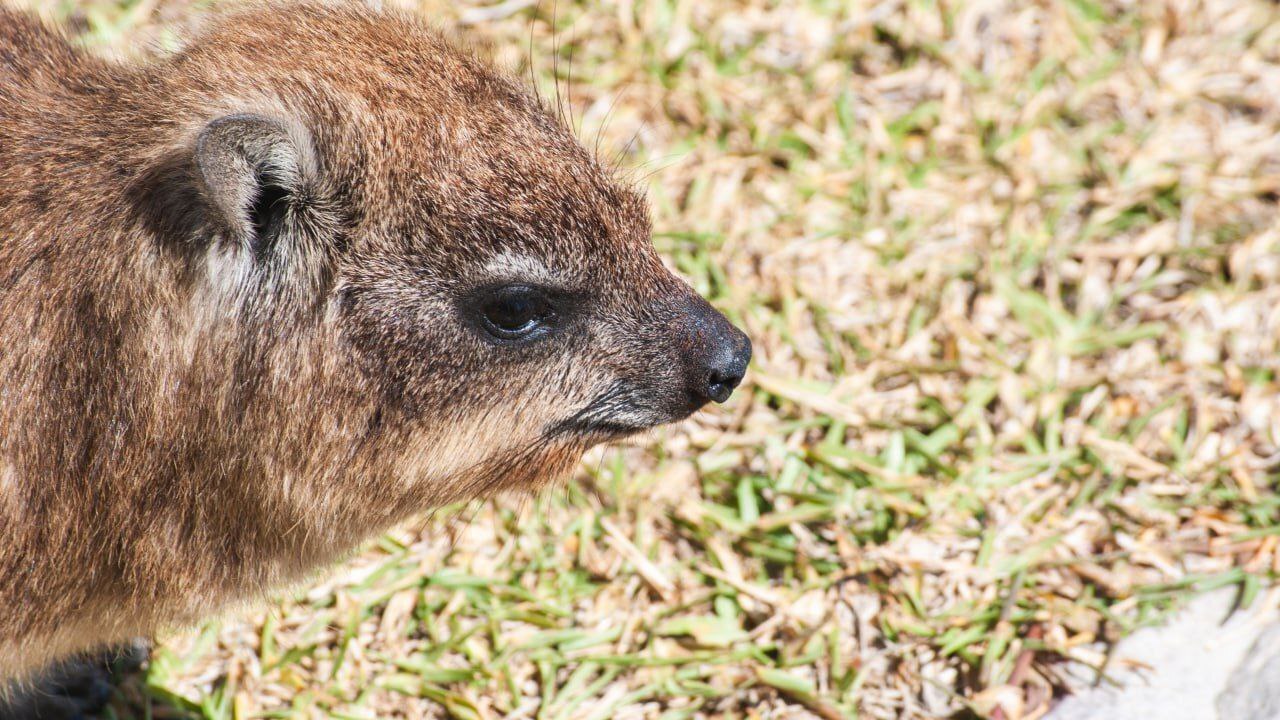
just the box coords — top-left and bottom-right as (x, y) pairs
(22, 0), (1280, 720)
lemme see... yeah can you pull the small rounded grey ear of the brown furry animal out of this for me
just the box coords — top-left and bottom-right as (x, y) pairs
(195, 114), (314, 259)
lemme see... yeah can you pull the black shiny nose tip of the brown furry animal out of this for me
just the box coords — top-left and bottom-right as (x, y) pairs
(687, 304), (751, 405)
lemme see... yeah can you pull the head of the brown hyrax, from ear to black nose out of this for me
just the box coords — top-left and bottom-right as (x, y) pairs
(131, 5), (751, 504)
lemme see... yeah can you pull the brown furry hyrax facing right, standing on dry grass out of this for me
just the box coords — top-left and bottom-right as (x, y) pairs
(0, 4), (750, 702)
